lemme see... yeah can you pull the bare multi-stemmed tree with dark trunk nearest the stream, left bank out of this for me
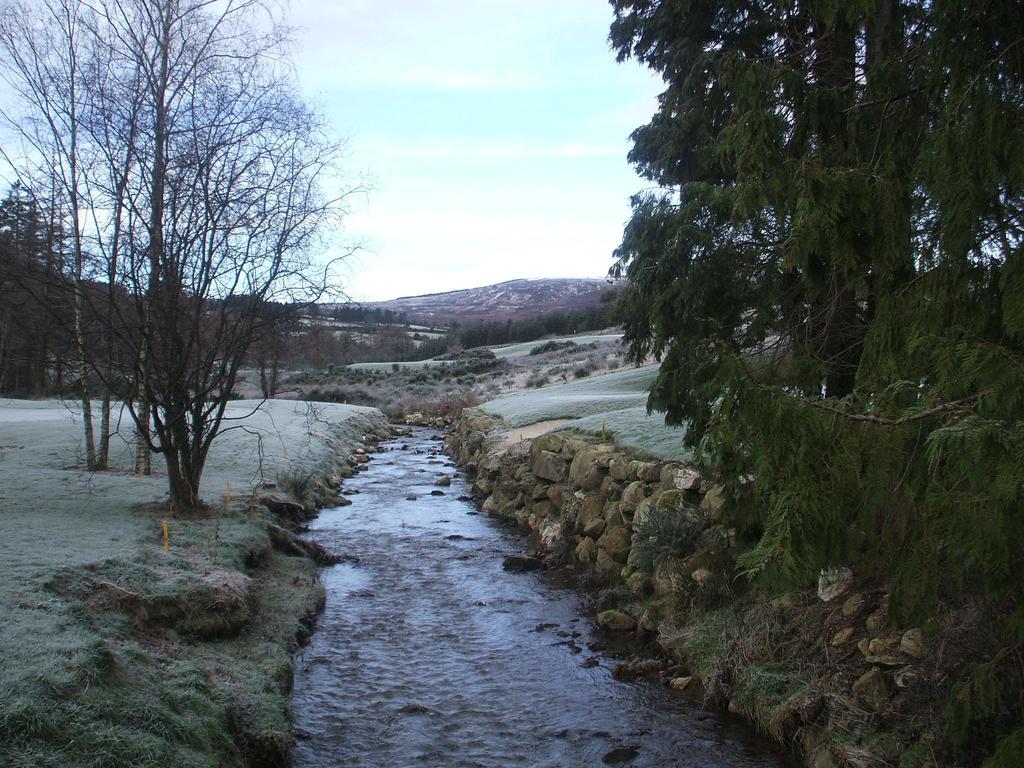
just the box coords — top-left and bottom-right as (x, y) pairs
(0, 0), (358, 509)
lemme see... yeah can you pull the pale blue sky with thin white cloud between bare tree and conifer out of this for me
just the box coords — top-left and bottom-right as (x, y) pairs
(287, 0), (660, 301)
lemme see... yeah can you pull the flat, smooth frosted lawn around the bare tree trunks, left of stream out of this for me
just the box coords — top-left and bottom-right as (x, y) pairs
(0, 399), (372, 586)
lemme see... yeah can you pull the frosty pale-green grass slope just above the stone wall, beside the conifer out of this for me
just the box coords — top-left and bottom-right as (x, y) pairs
(481, 366), (689, 459)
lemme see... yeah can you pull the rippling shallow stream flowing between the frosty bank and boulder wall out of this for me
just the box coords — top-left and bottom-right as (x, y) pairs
(292, 430), (785, 768)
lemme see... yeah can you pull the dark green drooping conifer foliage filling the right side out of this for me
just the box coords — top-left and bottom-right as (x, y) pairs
(610, 0), (1024, 753)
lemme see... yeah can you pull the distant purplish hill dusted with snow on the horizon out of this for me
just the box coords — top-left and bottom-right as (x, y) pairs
(365, 278), (612, 321)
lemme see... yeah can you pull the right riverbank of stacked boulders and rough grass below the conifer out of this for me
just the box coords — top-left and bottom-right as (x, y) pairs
(449, 410), (997, 768)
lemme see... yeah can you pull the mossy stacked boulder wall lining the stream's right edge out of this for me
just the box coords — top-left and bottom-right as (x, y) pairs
(447, 410), (734, 595)
